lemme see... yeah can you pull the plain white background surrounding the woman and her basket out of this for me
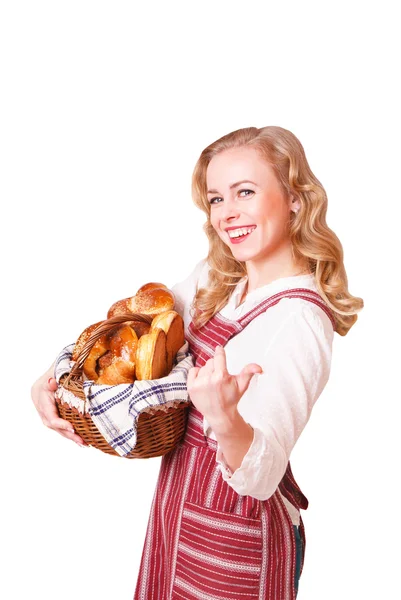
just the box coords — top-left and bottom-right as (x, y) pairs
(0, 0), (401, 600)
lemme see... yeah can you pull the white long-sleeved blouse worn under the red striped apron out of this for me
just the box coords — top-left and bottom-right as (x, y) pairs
(172, 260), (334, 525)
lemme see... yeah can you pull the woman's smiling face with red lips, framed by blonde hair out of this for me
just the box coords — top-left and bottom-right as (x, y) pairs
(206, 147), (299, 268)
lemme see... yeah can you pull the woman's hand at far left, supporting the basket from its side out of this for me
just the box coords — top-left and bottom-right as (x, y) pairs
(31, 369), (89, 446)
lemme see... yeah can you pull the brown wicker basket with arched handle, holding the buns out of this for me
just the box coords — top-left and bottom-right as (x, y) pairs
(56, 314), (189, 458)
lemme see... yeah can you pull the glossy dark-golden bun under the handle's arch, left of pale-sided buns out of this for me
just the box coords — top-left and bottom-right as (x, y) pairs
(83, 325), (138, 385)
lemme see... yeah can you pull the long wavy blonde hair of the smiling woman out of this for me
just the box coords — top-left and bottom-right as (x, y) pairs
(191, 126), (363, 336)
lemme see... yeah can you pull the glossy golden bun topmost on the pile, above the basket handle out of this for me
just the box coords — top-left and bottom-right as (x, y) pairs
(107, 283), (175, 319)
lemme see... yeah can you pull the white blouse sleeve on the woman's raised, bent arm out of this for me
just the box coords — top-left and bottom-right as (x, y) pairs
(214, 299), (333, 500)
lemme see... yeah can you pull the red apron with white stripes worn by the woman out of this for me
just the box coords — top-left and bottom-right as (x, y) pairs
(134, 288), (335, 600)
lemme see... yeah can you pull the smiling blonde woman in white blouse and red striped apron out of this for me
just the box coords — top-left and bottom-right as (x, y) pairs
(33, 127), (363, 600)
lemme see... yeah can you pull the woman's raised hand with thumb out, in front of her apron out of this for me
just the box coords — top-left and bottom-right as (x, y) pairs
(187, 346), (263, 424)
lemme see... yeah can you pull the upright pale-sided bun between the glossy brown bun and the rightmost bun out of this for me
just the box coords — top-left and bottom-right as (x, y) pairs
(136, 328), (167, 379)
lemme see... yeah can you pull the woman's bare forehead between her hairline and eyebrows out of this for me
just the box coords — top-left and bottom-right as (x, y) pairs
(206, 148), (274, 188)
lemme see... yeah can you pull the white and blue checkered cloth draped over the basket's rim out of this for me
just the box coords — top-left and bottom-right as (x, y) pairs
(54, 342), (194, 456)
